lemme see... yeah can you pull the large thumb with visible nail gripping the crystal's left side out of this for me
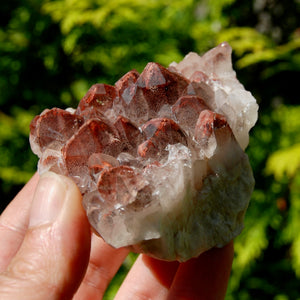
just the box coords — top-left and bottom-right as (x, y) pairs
(0, 172), (90, 300)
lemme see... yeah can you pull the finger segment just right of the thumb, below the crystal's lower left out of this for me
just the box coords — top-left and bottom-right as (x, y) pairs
(74, 234), (129, 300)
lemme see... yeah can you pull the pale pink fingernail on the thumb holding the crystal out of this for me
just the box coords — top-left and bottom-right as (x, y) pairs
(29, 172), (67, 227)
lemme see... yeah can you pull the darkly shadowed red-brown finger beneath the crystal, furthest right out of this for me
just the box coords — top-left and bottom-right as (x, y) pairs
(168, 242), (233, 300)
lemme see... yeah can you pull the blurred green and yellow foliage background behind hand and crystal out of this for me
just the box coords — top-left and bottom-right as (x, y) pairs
(0, 0), (300, 300)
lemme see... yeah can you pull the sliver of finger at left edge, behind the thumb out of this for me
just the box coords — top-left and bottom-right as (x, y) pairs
(0, 173), (39, 273)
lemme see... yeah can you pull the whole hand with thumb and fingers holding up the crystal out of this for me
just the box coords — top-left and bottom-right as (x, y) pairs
(0, 173), (233, 300)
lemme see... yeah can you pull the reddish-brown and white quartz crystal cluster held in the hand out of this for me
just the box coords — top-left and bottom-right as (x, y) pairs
(30, 43), (258, 261)
